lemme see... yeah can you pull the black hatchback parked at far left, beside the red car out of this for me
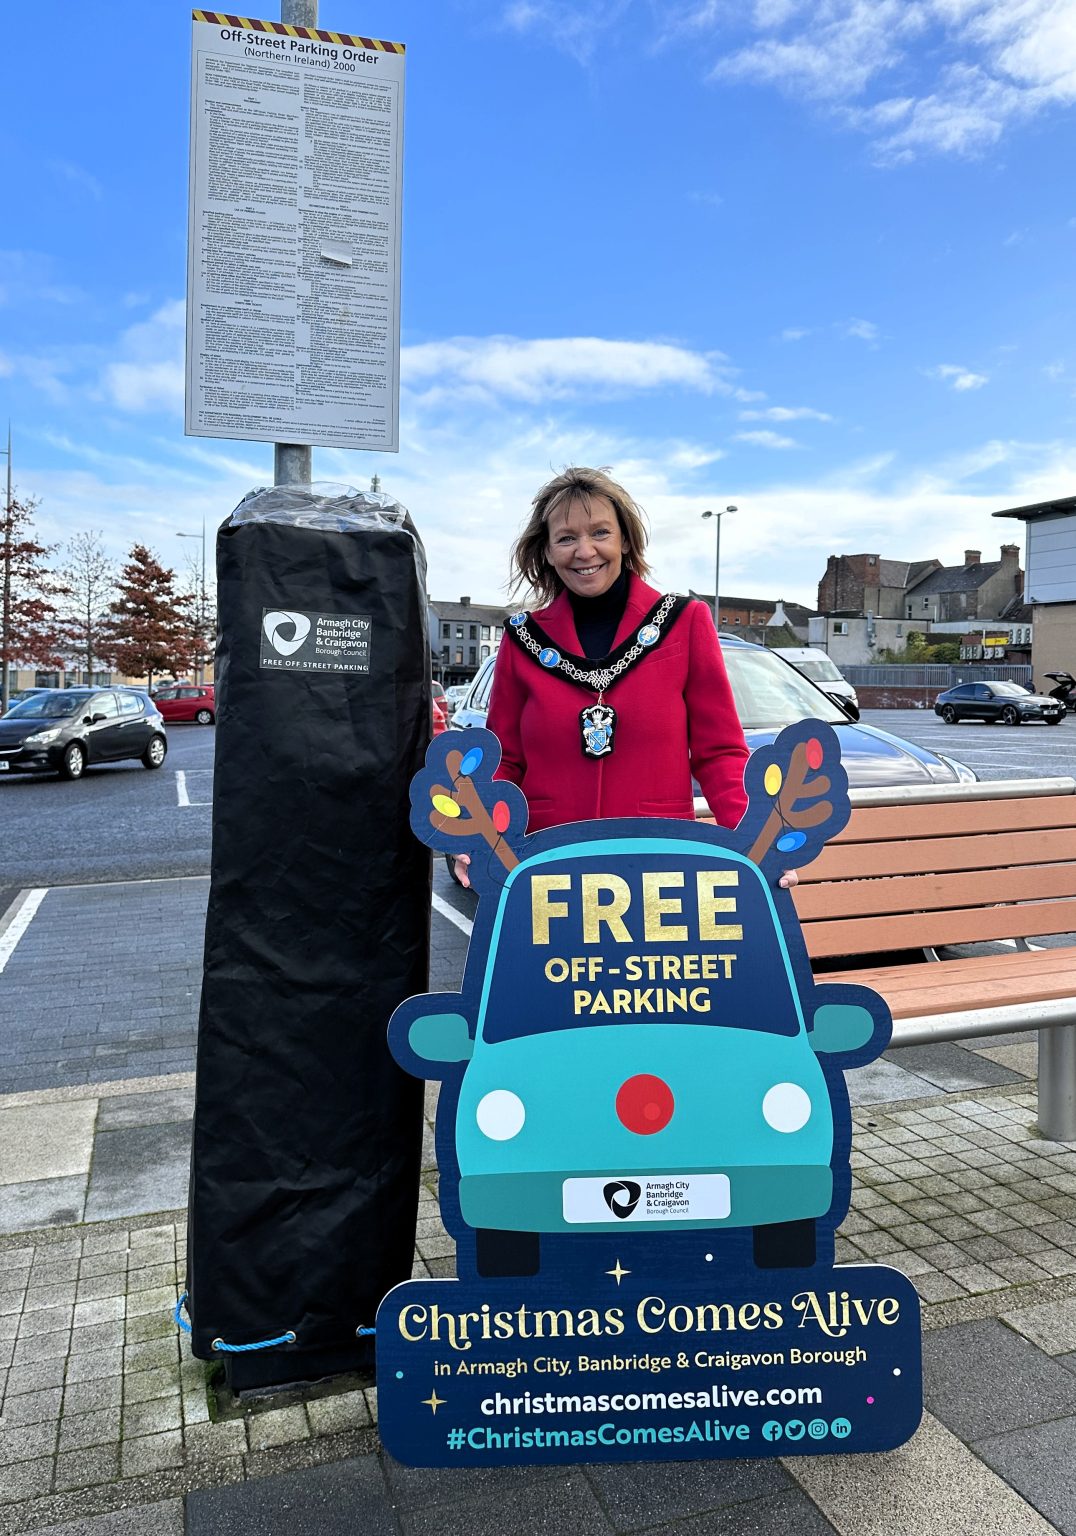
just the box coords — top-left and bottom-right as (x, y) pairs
(0, 688), (169, 779)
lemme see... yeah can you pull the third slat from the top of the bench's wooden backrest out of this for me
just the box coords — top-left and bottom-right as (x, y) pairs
(795, 863), (1076, 915)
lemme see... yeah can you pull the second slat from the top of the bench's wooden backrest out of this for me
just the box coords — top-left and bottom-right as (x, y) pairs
(800, 823), (1076, 885)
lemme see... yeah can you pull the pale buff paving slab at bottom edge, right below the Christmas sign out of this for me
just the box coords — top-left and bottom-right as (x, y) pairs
(786, 1413), (1053, 1536)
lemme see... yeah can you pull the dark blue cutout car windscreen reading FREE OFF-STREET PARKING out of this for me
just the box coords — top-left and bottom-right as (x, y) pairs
(480, 851), (801, 1043)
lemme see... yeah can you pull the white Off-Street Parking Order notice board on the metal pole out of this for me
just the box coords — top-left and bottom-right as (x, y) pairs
(186, 11), (404, 452)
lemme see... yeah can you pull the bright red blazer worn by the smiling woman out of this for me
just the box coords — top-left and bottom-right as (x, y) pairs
(487, 574), (748, 833)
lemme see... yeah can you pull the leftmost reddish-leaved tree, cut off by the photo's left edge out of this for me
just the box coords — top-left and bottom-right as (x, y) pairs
(0, 496), (63, 710)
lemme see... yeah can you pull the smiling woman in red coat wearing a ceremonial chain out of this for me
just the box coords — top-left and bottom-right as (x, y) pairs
(457, 468), (748, 879)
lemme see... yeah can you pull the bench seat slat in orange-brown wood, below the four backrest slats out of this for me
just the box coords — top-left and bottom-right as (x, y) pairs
(818, 948), (1076, 1018)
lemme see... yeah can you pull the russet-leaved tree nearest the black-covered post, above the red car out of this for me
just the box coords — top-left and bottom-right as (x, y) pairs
(98, 544), (192, 687)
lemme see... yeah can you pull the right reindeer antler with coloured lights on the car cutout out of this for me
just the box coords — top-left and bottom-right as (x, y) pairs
(746, 720), (849, 868)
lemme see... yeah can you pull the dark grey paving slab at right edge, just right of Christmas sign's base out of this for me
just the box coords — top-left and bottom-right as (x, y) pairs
(923, 1318), (1076, 1444)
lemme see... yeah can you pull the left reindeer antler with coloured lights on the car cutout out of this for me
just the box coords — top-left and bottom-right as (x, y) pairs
(411, 730), (526, 883)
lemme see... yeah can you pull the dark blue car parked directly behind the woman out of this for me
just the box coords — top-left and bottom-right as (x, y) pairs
(453, 634), (978, 790)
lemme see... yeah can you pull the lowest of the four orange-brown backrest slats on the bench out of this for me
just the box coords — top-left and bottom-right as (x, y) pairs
(797, 889), (1076, 958)
